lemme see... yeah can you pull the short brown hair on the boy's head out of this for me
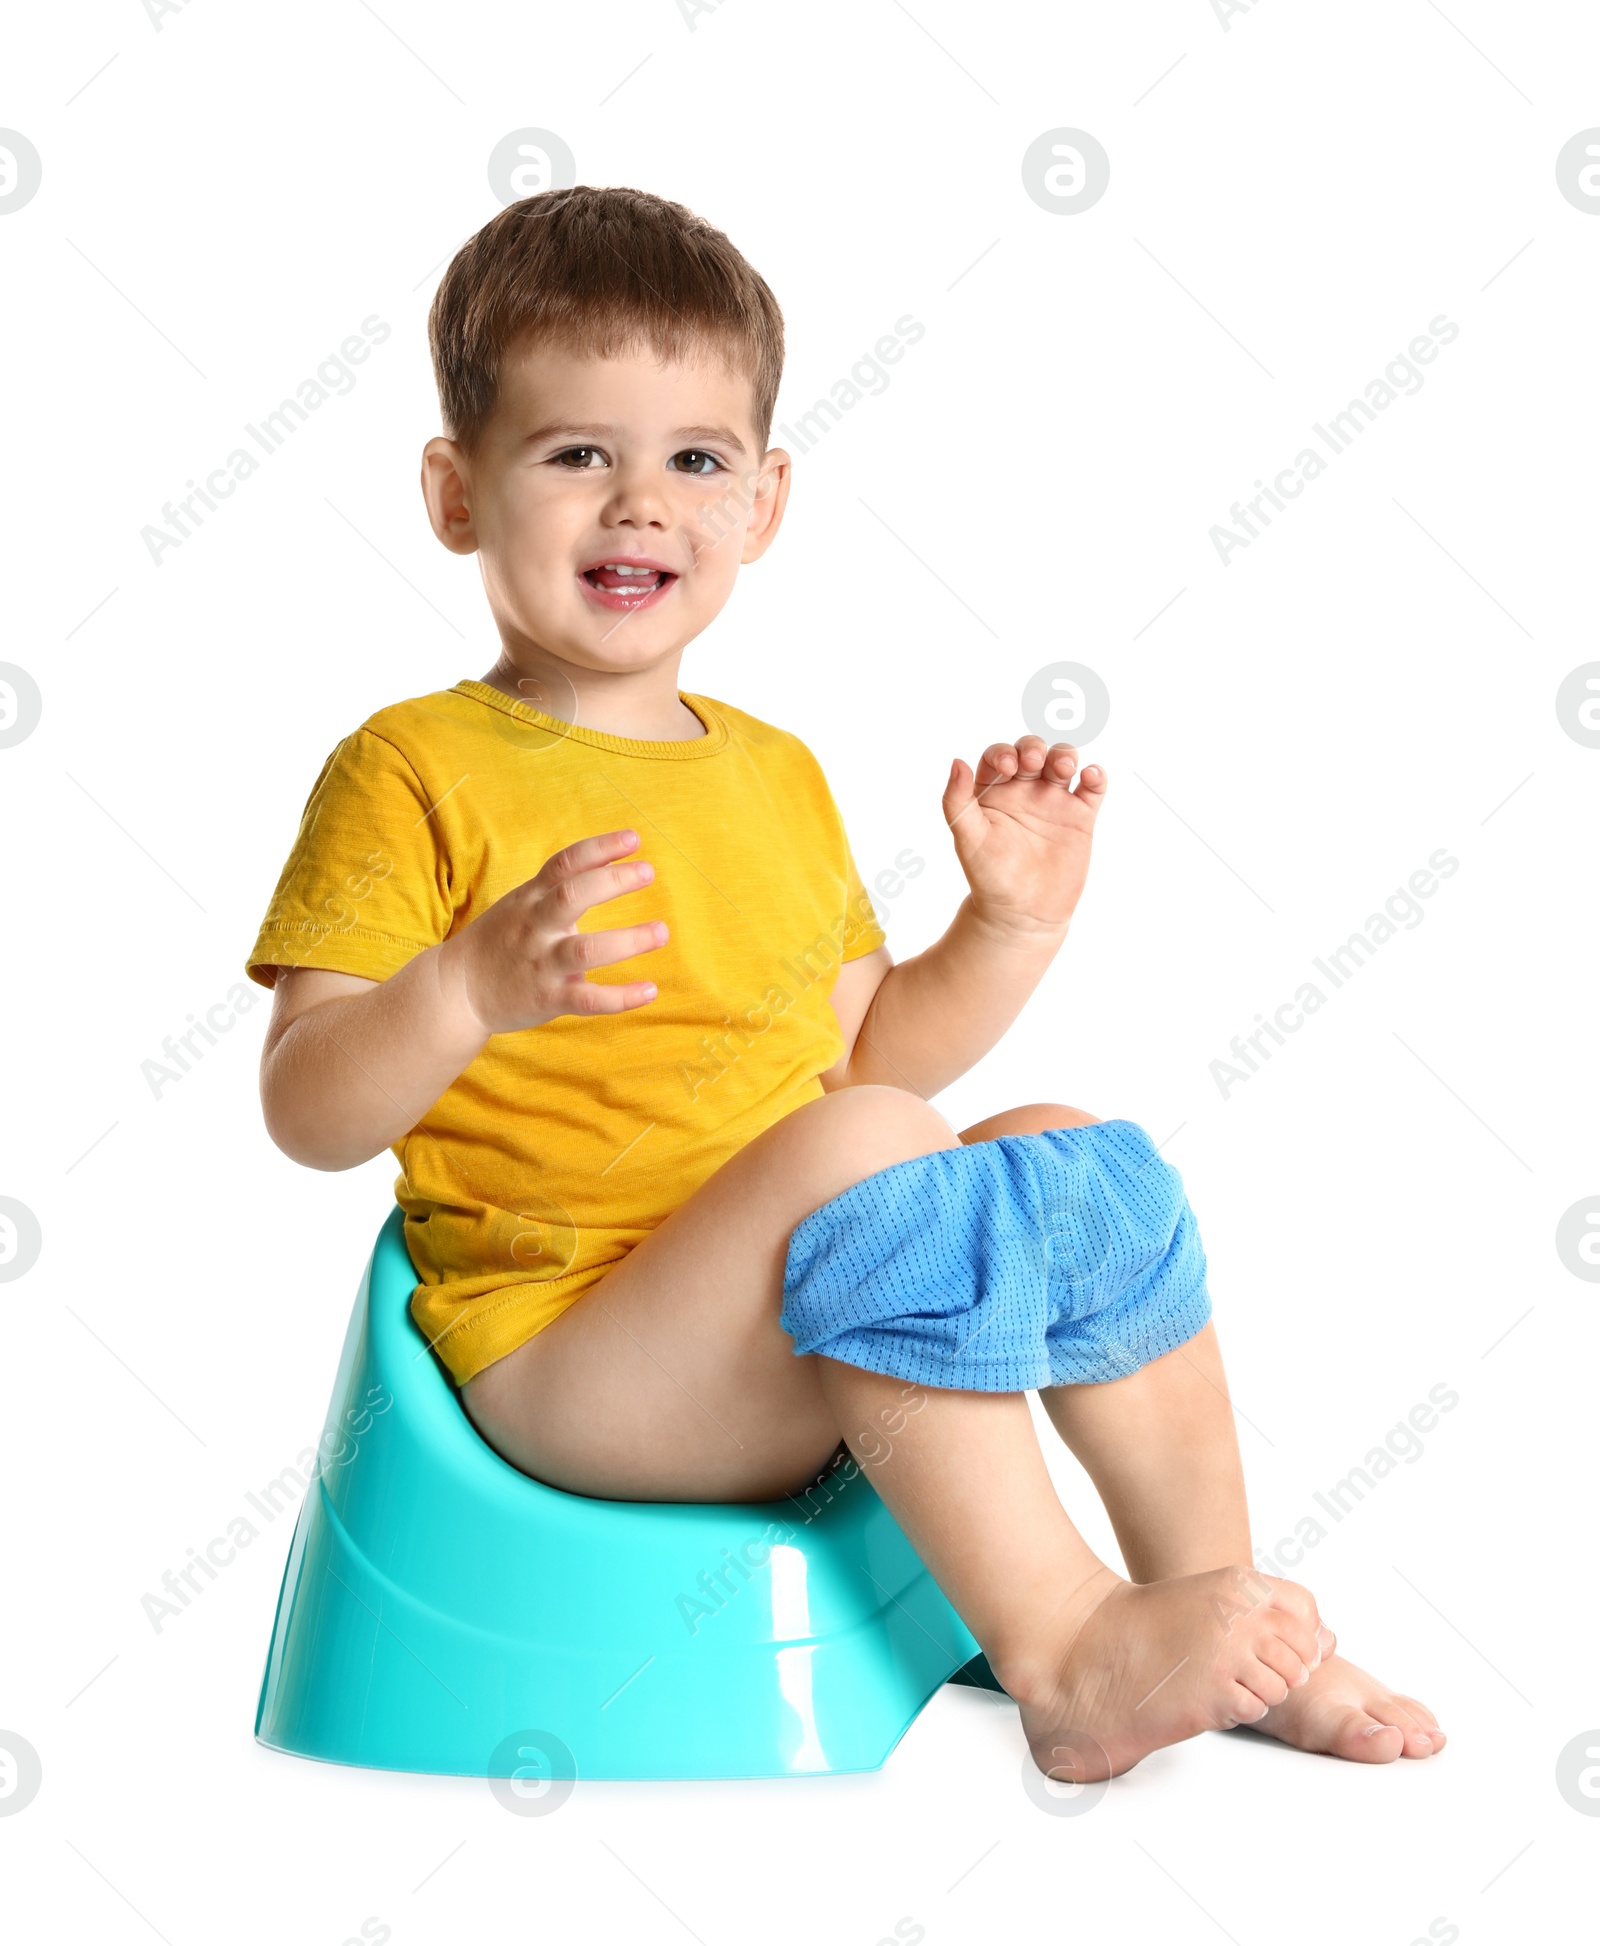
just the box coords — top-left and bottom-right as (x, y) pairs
(428, 183), (782, 453)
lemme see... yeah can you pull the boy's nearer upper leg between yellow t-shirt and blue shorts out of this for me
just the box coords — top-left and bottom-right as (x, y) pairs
(463, 1088), (958, 1500)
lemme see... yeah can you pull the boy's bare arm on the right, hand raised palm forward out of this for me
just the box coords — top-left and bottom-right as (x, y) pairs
(821, 736), (1106, 1098)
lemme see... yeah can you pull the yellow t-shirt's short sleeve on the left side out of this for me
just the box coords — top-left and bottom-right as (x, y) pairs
(245, 730), (452, 987)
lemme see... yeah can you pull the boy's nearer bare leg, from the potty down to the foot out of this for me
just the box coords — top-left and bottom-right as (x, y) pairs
(463, 1088), (1316, 1775)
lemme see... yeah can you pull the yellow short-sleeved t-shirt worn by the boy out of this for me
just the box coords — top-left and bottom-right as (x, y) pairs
(247, 681), (884, 1386)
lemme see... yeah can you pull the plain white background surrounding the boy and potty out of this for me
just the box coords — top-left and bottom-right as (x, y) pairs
(0, 0), (1600, 1946)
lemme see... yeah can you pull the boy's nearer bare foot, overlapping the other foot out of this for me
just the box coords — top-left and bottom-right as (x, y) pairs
(997, 1567), (1331, 1783)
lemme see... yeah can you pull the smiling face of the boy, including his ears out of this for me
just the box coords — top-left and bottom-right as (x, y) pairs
(422, 346), (788, 684)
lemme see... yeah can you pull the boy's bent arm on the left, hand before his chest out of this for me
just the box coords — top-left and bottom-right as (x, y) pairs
(261, 831), (666, 1170)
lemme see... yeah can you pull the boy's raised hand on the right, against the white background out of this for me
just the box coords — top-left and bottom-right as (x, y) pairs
(944, 736), (1106, 932)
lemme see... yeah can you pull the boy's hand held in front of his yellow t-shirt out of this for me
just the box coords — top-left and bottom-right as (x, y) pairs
(438, 831), (668, 1033)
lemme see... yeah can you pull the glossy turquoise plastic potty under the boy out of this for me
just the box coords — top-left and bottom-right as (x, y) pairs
(255, 1208), (997, 1788)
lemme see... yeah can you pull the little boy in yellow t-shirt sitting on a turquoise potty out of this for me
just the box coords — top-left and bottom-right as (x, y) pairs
(249, 187), (1444, 1779)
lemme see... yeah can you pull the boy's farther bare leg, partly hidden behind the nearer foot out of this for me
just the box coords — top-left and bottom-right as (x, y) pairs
(962, 1103), (1444, 1763)
